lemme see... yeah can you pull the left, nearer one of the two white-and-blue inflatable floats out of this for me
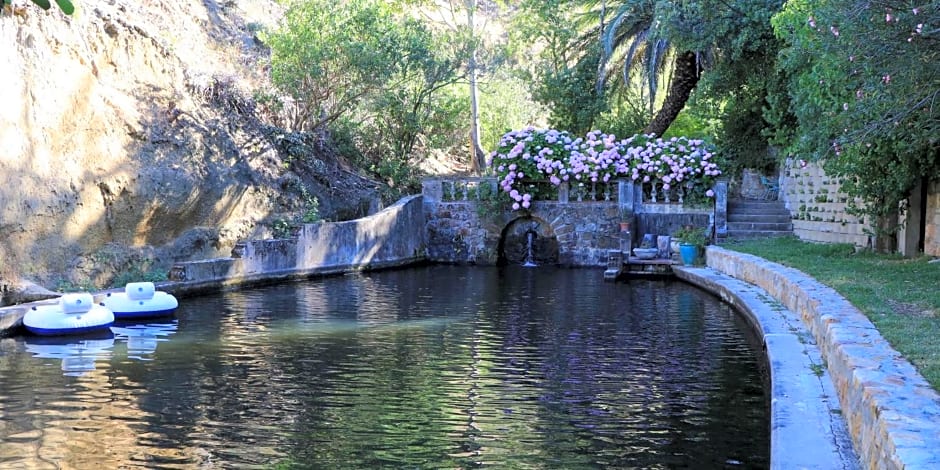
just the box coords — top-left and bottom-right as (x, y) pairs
(23, 293), (114, 336)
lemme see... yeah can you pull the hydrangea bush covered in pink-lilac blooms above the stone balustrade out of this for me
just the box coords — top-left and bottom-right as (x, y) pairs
(491, 127), (721, 210)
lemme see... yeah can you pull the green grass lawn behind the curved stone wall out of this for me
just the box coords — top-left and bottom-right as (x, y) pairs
(722, 237), (940, 390)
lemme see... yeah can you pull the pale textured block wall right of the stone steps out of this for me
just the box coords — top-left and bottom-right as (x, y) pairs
(780, 159), (872, 247)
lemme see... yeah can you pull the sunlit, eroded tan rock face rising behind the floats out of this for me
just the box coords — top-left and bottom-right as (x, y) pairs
(0, 0), (378, 285)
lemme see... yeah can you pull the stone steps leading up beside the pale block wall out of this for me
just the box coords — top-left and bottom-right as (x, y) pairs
(728, 199), (793, 240)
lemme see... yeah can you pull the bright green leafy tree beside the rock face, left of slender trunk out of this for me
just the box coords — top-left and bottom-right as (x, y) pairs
(264, 0), (466, 198)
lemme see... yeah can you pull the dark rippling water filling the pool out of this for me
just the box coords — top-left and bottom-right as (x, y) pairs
(0, 266), (769, 469)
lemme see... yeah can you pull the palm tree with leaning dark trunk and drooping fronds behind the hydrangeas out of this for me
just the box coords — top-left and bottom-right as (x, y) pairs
(585, 0), (782, 135)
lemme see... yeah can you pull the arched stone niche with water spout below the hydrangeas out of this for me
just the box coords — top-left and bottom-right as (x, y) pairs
(499, 216), (558, 265)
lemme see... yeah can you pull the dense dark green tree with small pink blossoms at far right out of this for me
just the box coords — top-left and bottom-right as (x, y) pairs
(772, 0), (940, 249)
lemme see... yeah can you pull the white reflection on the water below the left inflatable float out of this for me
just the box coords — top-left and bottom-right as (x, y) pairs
(24, 332), (114, 377)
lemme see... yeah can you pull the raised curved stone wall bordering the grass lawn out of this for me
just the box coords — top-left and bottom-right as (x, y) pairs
(707, 246), (940, 469)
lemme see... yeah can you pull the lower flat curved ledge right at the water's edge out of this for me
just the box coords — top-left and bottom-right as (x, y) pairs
(673, 266), (859, 469)
